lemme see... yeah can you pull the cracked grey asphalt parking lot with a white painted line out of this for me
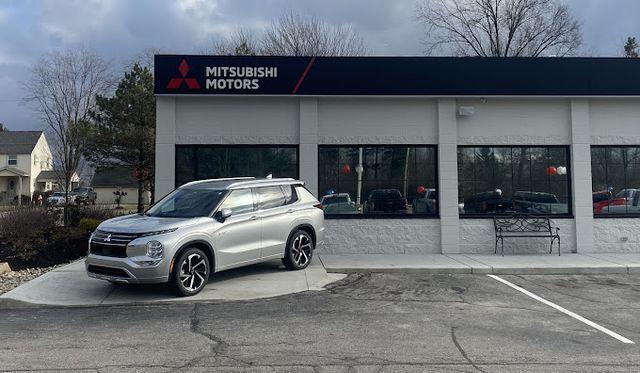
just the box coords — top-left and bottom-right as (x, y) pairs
(0, 273), (640, 372)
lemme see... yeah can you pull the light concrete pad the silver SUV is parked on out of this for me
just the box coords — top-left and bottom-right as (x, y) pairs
(0, 258), (346, 307)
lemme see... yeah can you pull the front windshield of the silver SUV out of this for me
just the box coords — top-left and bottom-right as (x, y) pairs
(145, 188), (226, 218)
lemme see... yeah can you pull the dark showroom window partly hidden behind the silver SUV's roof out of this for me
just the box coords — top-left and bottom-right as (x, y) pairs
(176, 145), (298, 186)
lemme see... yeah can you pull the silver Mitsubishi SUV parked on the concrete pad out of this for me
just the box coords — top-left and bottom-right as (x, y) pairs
(85, 178), (324, 296)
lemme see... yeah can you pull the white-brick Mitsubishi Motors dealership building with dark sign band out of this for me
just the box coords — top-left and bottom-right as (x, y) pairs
(155, 55), (640, 254)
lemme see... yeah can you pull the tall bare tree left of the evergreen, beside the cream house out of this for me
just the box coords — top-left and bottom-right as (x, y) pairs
(23, 48), (113, 218)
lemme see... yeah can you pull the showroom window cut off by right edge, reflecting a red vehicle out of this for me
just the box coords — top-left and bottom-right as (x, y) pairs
(591, 146), (640, 216)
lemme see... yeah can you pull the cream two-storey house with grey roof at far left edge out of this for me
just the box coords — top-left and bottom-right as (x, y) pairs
(0, 131), (56, 204)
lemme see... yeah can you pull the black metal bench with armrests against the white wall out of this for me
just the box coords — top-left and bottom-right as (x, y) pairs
(493, 214), (560, 256)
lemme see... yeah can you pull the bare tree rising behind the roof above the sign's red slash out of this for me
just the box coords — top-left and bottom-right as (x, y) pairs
(261, 12), (367, 56)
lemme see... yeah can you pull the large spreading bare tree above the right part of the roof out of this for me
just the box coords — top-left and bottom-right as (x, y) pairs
(416, 0), (582, 57)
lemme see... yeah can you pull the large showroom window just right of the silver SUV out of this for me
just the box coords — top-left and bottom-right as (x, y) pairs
(318, 145), (438, 217)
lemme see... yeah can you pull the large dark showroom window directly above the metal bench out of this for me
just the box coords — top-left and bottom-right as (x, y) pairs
(458, 146), (571, 216)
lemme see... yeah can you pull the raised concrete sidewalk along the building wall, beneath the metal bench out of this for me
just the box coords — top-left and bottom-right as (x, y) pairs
(319, 254), (640, 275)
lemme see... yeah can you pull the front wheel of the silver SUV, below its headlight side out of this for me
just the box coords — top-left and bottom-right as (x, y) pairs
(172, 247), (211, 296)
